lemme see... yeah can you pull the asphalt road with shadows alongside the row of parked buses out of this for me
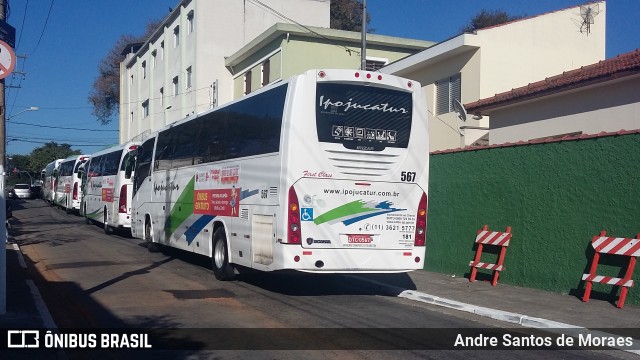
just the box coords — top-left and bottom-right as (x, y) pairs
(7, 200), (632, 359)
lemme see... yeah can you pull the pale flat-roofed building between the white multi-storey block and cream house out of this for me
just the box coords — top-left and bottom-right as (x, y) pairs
(225, 24), (435, 99)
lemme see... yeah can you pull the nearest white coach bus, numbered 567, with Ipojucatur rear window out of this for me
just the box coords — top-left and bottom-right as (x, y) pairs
(132, 70), (429, 280)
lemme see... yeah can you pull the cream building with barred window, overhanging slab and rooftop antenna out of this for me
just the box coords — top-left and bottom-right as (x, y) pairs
(380, 1), (606, 151)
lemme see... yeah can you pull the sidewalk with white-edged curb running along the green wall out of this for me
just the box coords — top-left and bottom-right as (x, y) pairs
(372, 271), (640, 329)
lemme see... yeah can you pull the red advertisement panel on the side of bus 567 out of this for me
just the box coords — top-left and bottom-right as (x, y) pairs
(193, 186), (242, 217)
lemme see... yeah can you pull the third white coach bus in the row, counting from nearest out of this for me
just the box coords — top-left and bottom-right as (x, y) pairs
(53, 155), (89, 213)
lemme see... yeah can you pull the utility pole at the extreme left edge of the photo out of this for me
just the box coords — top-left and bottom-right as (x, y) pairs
(0, 0), (7, 315)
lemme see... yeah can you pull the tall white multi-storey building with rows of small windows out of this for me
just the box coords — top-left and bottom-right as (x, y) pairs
(119, 0), (330, 143)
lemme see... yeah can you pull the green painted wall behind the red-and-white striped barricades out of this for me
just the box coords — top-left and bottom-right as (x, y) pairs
(425, 133), (640, 305)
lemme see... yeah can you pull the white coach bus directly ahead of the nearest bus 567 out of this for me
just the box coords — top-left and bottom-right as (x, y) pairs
(81, 142), (140, 234)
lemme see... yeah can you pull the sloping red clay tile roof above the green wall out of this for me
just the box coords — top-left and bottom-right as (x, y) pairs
(465, 49), (640, 113)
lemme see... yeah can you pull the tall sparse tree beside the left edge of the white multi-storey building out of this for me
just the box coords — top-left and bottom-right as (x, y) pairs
(89, 20), (162, 125)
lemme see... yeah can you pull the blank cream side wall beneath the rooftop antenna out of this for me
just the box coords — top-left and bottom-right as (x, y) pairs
(478, 1), (606, 101)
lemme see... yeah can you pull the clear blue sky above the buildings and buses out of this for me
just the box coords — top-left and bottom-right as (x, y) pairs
(6, 0), (640, 155)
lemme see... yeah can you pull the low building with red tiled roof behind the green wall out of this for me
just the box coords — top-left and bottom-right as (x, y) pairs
(465, 49), (640, 144)
